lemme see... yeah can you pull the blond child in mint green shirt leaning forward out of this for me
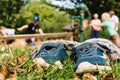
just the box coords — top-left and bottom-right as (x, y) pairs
(101, 12), (120, 48)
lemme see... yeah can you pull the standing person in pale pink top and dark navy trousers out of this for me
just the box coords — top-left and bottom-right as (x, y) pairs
(89, 13), (101, 38)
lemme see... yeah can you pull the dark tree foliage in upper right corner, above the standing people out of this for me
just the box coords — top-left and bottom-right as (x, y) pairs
(85, 0), (120, 16)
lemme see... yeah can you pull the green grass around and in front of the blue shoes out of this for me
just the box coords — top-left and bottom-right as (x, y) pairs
(0, 44), (120, 80)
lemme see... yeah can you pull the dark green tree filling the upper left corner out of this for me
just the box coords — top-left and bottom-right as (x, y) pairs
(0, 0), (24, 28)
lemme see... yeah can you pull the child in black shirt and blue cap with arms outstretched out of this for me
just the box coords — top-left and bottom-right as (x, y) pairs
(17, 14), (43, 46)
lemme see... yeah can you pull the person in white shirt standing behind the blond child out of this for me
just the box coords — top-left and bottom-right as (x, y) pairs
(109, 10), (119, 31)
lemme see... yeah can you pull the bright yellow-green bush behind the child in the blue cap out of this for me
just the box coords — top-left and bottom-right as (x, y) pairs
(19, 2), (71, 33)
